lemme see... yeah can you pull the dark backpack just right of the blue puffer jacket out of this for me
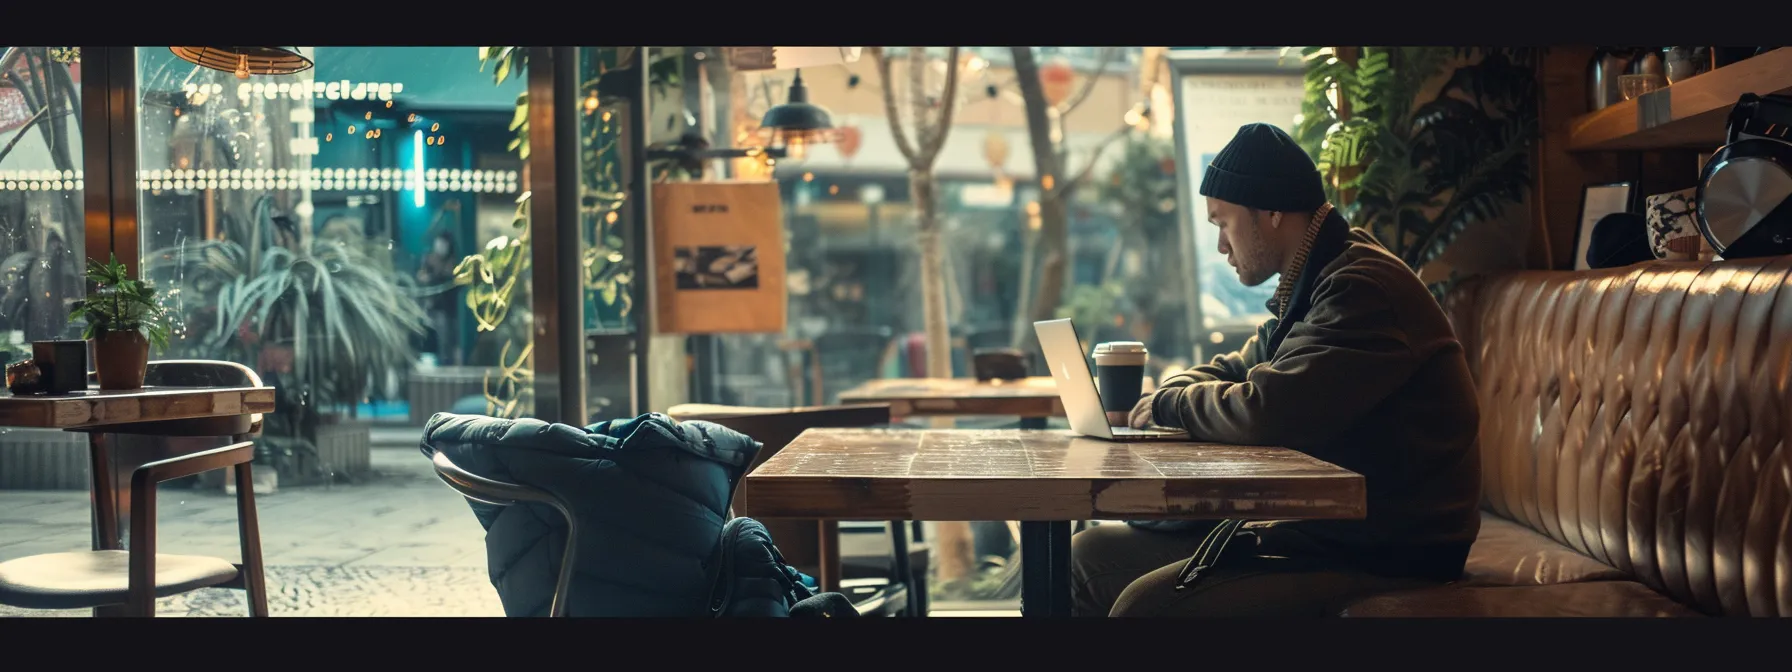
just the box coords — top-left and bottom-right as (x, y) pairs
(710, 518), (858, 618)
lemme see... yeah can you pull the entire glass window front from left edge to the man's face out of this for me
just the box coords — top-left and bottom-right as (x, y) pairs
(0, 47), (1275, 615)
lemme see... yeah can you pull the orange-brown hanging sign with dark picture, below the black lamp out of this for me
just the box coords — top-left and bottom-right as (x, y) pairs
(652, 181), (787, 333)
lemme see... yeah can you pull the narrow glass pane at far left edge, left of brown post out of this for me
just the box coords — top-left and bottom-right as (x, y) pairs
(0, 47), (88, 494)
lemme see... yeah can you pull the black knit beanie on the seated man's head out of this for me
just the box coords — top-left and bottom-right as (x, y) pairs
(1201, 124), (1326, 211)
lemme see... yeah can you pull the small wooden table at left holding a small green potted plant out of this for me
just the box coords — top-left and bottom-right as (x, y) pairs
(0, 387), (274, 615)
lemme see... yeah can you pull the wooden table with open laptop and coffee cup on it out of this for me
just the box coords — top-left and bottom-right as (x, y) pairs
(740, 428), (1367, 616)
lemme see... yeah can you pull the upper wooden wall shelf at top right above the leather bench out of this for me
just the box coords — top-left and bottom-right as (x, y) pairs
(1568, 48), (1792, 152)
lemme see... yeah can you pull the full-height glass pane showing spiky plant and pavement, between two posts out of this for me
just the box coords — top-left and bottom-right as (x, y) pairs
(122, 47), (534, 615)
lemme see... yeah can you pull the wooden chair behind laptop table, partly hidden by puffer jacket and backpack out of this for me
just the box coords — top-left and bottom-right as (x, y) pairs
(668, 403), (928, 616)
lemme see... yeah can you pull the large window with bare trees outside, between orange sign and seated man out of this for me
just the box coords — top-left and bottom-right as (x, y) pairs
(699, 47), (1192, 405)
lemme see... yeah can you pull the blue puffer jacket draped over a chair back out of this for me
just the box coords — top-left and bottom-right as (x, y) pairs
(421, 414), (762, 616)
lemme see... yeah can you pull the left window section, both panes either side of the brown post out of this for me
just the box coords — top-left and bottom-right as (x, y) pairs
(0, 47), (536, 616)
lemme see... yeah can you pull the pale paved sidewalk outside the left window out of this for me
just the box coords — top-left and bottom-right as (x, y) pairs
(0, 446), (504, 616)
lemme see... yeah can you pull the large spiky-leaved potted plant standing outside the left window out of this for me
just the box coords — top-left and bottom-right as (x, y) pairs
(145, 204), (425, 484)
